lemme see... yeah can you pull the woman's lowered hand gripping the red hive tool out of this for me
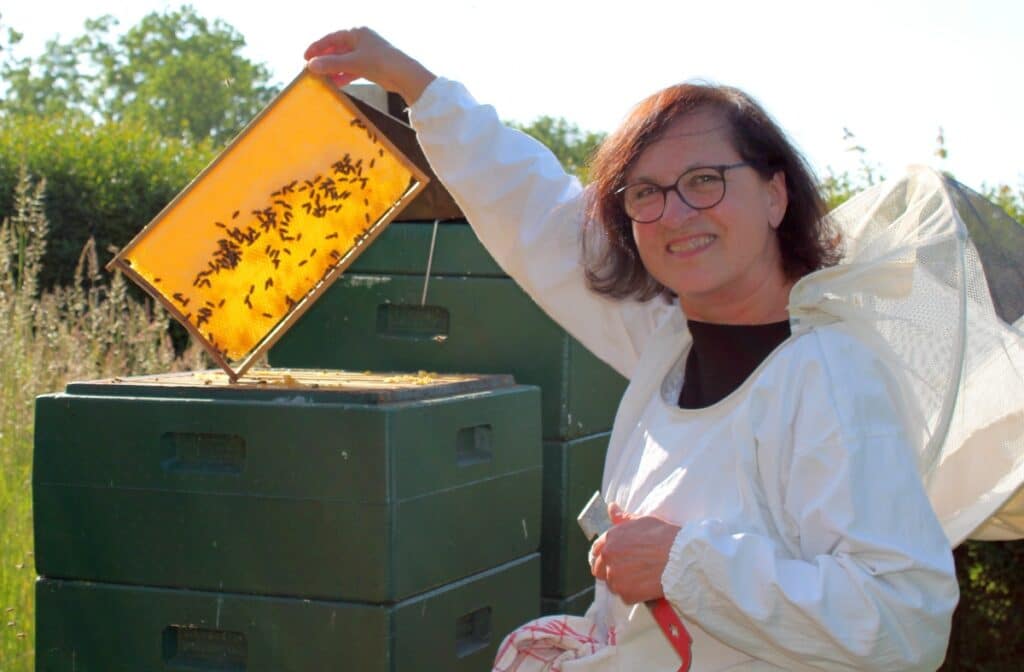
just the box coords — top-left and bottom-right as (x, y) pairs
(591, 503), (679, 604)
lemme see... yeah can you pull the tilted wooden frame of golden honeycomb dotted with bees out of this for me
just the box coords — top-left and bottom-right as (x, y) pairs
(109, 71), (428, 380)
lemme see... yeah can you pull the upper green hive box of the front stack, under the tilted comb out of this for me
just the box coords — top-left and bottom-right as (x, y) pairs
(33, 371), (542, 602)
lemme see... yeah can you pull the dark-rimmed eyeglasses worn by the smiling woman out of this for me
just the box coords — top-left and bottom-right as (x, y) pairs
(615, 161), (750, 224)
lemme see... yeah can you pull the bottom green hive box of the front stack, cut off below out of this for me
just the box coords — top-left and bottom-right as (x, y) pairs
(36, 554), (540, 672)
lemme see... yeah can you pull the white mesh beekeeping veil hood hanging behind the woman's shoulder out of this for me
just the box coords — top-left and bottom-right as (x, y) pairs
(790, 168), (1024, 546)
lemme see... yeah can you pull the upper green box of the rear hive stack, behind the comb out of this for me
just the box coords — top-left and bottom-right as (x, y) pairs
(269, 222), (626, 440)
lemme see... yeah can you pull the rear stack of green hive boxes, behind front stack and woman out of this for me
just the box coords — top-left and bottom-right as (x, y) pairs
(270, 221), (626, 613)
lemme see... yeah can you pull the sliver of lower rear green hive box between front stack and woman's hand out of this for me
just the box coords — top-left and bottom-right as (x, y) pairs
(541, 432), (609, 594)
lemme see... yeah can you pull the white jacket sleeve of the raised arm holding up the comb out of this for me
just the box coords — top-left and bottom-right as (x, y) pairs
(410, 78), (679, 377)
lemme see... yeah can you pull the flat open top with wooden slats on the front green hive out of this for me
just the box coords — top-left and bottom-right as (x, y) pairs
(67, 369), (515, 405)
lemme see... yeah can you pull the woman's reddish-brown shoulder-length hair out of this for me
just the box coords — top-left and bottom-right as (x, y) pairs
(583, 83), (841, 300)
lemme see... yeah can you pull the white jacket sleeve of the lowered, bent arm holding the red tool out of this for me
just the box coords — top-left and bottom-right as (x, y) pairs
(663, 325), (958, 670)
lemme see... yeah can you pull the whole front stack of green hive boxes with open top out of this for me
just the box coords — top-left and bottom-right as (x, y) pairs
(33, 372), (542, 672)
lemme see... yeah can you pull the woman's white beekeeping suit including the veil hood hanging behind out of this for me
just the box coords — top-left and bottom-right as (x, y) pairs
(410, 79), (1024, 672)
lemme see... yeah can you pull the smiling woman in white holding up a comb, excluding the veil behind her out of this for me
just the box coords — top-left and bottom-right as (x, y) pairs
(306, 29), (957, 671)
